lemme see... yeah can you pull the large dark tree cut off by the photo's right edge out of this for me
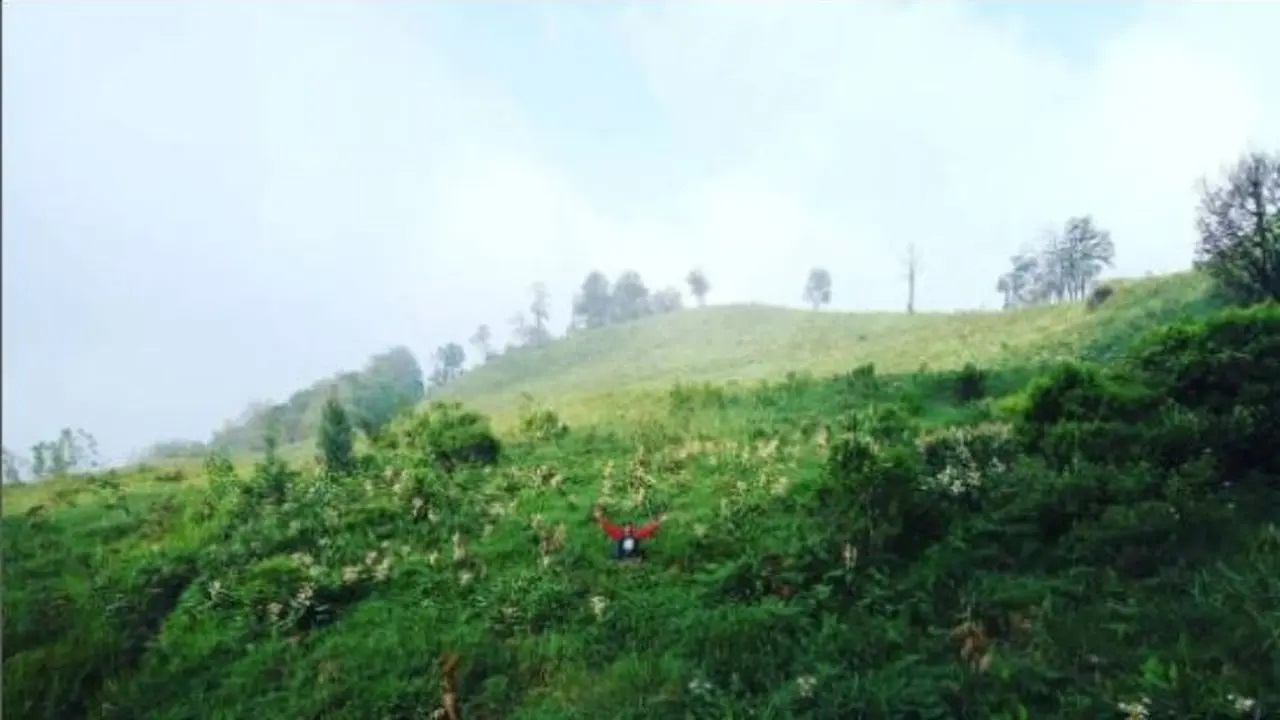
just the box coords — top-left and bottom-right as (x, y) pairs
(1196, 152), (1280, 302)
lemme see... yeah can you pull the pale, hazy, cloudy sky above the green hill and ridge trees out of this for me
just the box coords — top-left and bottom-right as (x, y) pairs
(0, 0), (1280, 460)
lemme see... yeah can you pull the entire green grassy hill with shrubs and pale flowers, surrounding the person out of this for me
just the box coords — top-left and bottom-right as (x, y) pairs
(10, 271), (1280, 720)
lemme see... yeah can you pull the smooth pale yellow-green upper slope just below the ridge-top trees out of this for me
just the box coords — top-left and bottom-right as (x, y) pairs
(431, 273), (1208, 420)
